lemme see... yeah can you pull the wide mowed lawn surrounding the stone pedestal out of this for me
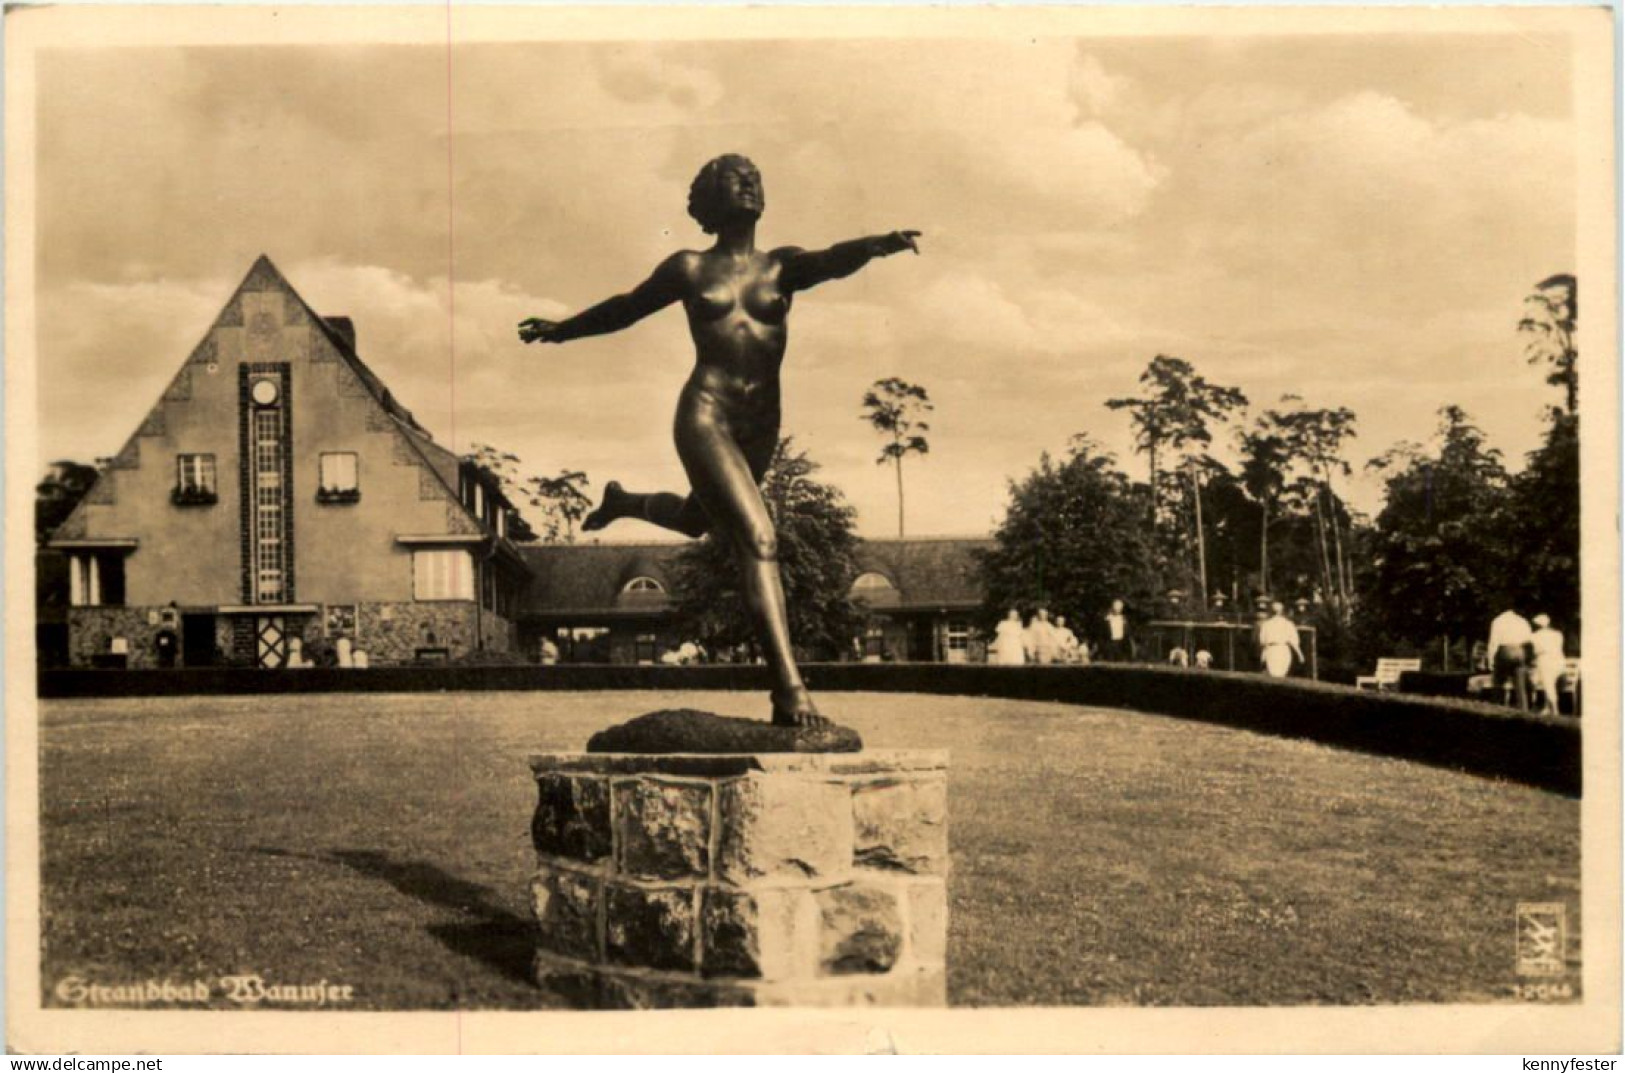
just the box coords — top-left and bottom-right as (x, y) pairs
(41, 693), (1580, 1010)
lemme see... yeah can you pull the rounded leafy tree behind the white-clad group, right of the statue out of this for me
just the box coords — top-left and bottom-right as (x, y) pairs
(982, 436), (1157, 634)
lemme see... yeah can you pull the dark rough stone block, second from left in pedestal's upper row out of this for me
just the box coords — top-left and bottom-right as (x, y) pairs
(614, 779), (712, 880)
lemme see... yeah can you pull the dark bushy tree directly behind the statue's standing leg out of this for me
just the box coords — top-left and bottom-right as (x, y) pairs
(673, 436), (863, 658)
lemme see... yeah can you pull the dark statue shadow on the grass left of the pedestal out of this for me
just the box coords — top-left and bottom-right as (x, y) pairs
(255, 845), (535, 985)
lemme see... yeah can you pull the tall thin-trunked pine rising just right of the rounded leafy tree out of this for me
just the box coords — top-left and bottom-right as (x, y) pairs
(1107, 354), (1246, 608)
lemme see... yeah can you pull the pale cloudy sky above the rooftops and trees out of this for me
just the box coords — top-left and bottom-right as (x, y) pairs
(36, 27), (1576, 538)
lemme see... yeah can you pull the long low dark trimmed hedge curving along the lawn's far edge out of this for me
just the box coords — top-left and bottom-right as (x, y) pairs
(41, 663), (1580, 795)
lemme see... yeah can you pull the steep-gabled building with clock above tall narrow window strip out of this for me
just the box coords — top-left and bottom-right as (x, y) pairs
(49, 257), (530, 668)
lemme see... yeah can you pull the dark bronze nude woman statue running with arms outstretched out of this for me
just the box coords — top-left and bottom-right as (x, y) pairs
(518, 154), (920, 727)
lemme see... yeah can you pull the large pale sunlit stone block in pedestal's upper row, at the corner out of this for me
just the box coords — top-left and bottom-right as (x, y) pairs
(717, 775), (852, 883)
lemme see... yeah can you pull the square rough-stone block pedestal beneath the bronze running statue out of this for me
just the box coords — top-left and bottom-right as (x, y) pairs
(531, 751), (947, 1010)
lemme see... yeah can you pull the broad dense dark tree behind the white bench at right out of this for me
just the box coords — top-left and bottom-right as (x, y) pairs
(1362, 406), (1516, 647)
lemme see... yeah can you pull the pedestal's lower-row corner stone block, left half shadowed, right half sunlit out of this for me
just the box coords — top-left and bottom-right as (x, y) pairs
(700, 888), (819, 979)
